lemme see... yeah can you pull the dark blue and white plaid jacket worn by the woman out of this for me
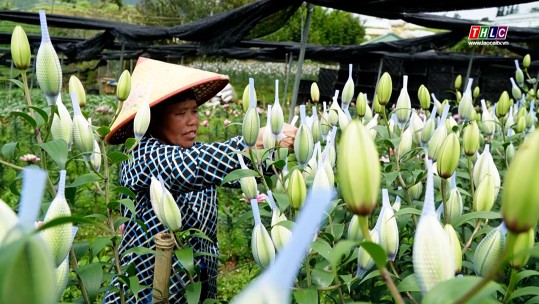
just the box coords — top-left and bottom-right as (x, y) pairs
(103, 136), (245, 303)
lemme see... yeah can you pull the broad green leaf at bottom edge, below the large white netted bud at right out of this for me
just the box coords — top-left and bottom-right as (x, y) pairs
(421, 276), (498, 304)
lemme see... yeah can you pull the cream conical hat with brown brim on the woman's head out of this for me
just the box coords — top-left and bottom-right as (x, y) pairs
(105, 57), (228, 144)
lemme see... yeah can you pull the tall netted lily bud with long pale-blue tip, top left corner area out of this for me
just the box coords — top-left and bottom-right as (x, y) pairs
(36, 10), (62, 105)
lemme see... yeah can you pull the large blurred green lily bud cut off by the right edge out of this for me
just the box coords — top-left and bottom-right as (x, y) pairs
(502, 132), (539, 233)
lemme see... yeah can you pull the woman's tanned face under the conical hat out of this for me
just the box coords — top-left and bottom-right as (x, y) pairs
(155, 99), (198, 148)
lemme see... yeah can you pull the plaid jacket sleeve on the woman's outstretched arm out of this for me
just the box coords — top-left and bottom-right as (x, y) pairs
(129, 136), (245, 193)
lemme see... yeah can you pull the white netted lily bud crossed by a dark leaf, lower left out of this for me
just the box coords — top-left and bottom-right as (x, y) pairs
(42, 170), (73, 266)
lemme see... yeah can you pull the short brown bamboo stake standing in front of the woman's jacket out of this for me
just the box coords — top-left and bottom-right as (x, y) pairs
(152, 232), (174, 304)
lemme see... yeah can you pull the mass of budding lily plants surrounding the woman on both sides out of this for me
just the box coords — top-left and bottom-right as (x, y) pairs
(0, 12), (539, 303)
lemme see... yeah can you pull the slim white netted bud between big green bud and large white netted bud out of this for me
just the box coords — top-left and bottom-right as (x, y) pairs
(379, 189), (399, 261)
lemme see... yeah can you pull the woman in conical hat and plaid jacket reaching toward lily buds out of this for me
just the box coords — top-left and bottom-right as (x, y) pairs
(104, 58), (296, 303)
